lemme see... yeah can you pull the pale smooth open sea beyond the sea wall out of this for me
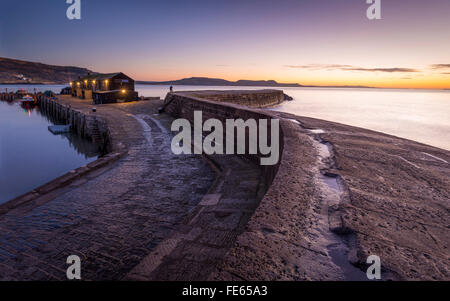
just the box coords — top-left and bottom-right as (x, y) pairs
(137, 85), (450, 150)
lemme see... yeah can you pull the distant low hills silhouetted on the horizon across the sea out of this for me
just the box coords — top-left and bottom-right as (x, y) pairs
(137, 77), (302, 87)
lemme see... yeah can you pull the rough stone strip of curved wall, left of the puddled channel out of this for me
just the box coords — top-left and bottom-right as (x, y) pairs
(165, 91), (330, 281)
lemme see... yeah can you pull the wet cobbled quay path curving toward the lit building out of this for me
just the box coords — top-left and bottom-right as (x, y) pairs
(0, 105), (216, 280)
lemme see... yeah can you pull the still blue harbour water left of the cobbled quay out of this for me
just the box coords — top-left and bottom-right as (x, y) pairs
(0, 94), (98, 204)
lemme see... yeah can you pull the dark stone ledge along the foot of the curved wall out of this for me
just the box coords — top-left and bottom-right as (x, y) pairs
(124, 111), (266, 281)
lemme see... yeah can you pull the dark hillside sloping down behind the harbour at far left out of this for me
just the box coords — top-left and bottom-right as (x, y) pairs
(0, 57), (92, 84)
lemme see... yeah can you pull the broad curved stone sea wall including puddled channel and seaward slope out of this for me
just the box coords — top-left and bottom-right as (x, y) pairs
(165, 91), (450, 281)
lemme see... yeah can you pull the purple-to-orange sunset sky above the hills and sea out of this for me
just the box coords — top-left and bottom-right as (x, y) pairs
(0, 0), (450, 88)
